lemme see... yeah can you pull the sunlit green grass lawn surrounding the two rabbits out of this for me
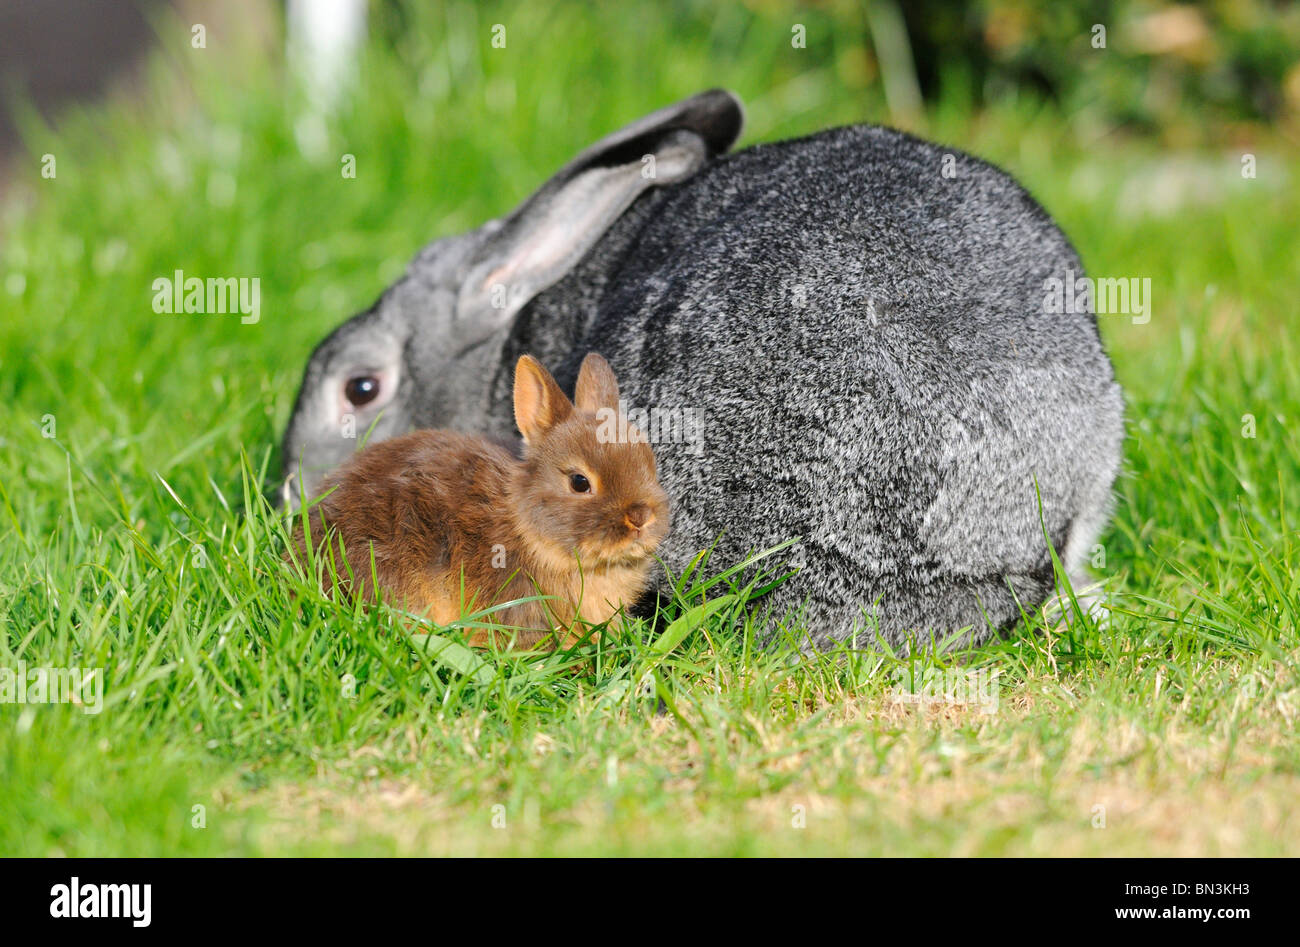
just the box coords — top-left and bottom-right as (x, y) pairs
(0, 4), (1300, 855)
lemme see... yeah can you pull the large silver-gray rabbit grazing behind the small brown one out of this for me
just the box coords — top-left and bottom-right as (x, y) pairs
(282, 90), (1123, 647)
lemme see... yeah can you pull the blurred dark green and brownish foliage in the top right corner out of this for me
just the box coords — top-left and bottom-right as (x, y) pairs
(894, 0), (1300, 130)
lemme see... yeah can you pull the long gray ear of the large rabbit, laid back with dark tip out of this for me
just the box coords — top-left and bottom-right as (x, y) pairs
(456, 90), (744, 341)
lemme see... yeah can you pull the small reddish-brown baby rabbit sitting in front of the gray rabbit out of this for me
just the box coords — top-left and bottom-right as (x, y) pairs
(286, 353), (668, 647)
